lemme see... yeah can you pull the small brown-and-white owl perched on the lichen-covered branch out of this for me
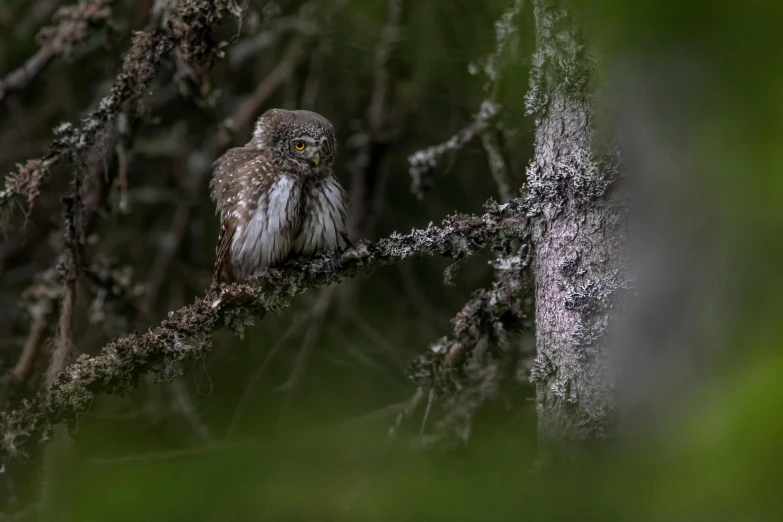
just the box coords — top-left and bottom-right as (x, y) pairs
(210, 109), (349, 283)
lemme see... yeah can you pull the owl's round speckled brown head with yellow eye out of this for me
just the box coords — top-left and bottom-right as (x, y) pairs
(253, 109), (337, 172)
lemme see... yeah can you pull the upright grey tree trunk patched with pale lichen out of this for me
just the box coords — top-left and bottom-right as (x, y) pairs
(526, 0), (625, 456)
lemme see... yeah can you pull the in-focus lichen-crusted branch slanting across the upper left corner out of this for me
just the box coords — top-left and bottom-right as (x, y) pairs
(0, 0), (233, 228)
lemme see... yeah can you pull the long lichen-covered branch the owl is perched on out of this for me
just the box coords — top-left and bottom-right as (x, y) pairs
(0, 199), (527, 464)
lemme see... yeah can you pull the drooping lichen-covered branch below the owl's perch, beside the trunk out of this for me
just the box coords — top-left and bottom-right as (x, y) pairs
(407, 243), (533, 445)
